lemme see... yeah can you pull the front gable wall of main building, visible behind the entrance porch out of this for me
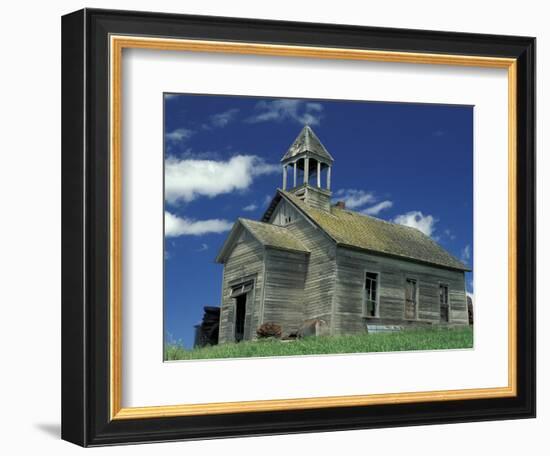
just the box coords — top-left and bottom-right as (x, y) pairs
(270, 200), (336, 327)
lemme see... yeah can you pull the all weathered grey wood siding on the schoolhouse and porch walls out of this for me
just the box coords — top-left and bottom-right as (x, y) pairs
(219, 199), (468, 343)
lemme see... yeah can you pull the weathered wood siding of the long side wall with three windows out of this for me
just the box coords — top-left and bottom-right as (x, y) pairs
(332, 247), (468, 334)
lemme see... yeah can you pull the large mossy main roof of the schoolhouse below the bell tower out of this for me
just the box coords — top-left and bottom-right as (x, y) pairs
(266, 190), (470, 271)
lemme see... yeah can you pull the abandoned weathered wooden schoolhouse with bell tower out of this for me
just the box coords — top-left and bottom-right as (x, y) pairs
(216, 126), (469, 343)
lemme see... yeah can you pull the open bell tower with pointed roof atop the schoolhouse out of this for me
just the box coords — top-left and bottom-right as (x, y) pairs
(281, 125), (334, 211)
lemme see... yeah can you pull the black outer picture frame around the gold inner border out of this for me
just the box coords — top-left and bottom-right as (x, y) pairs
(62, 9), (536, 446)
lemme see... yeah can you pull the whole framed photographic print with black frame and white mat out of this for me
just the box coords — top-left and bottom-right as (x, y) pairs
(62, 9), (535, 446)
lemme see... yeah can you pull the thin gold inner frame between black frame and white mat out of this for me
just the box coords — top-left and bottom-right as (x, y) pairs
(109, 35), (517, 420)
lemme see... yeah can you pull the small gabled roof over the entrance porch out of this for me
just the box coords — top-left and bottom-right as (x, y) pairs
(216, 218), (309, 263)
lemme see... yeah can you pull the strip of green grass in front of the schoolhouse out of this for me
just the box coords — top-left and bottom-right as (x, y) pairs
(164, 327), (473, 361)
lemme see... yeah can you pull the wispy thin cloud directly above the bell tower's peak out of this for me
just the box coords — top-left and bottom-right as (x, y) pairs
(246, 99), (323, 125)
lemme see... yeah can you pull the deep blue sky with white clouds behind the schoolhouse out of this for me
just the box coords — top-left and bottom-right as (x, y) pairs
(164, 94), (473, 347)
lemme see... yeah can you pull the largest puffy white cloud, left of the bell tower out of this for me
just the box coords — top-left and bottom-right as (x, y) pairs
(165, 155), (280, 204)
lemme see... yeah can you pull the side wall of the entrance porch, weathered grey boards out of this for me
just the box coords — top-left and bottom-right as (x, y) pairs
(260, 249), (308, 336)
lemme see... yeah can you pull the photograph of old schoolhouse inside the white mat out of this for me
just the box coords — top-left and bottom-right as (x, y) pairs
(163, 93), (475, 361)
